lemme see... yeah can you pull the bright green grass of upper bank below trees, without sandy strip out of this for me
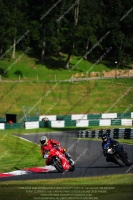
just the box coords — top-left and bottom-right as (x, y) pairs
(0, 52), (114, 80)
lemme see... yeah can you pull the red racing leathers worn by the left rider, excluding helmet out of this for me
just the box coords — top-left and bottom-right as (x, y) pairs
(41, 139), (65, 165)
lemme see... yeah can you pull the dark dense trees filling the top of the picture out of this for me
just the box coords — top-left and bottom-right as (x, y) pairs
(0, 0), (133, 69)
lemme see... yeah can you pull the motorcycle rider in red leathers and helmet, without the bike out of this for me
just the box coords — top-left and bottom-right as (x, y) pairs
(40, 136), (71, 165)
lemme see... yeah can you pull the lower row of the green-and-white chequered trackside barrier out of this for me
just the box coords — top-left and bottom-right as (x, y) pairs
(0, 119), (133, 130)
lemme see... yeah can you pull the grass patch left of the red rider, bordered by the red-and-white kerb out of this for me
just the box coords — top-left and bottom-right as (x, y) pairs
(0, 133), (44, 172)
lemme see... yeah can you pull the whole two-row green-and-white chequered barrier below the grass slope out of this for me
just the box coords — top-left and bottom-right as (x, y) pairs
(0, 112), (133, 130)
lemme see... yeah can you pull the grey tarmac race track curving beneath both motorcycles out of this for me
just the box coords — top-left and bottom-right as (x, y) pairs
(0, 132), (133, 181)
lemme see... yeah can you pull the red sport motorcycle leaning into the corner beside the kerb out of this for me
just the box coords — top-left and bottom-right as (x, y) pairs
(48, 147), (75, 173)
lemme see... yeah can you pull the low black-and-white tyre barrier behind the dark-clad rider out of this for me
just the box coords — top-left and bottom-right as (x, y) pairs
(78, 128), (133, 139)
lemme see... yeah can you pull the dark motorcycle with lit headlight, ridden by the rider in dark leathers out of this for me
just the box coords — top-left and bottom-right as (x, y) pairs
(106, 145), (131, 167)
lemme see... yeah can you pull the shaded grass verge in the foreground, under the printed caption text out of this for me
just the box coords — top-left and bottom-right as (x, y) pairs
(0, 174), (133, 200)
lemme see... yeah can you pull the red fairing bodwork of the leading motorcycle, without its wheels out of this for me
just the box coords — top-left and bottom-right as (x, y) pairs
(48, 148), (71, 170)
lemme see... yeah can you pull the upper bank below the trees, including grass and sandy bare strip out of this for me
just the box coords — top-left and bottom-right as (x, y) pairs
(0, 52), (133, 81)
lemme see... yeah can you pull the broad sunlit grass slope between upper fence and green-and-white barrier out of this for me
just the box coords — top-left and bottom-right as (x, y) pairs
(0, 79), (133, 117)
